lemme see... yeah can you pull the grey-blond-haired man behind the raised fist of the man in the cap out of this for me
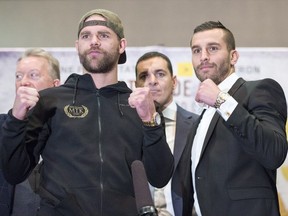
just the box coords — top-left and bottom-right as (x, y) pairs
(0, 48), (60, 216)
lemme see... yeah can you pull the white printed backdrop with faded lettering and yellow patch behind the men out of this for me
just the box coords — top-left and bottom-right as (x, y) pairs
(0, 46), (288, 216)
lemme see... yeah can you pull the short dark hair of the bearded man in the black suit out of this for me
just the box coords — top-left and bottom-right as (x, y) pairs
(190, 21), (236, 51)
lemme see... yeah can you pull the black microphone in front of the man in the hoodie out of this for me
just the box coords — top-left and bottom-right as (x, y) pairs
(131, 160), (158, 216)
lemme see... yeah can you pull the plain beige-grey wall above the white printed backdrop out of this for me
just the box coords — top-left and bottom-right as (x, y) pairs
(0, 0), (288, 47)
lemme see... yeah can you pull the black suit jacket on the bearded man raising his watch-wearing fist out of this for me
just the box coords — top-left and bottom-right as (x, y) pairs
(181, 78), (288, 216)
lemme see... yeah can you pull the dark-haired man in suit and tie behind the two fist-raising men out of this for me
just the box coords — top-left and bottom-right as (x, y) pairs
(135, 52), (198, 216)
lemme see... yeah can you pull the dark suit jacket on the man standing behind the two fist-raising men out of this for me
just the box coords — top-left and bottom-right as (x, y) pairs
(171, 105), (199, 216)
